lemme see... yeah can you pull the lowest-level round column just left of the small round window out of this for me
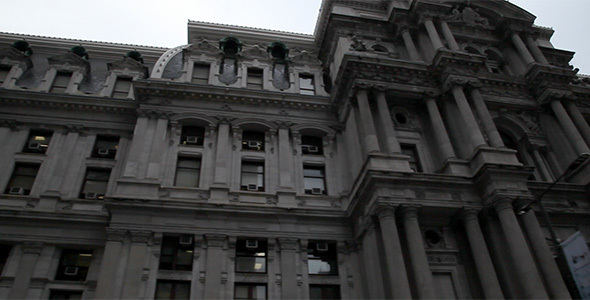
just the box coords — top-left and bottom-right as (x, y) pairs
(401, 207), (436, 299)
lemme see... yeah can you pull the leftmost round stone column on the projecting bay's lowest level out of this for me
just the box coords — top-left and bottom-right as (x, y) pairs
(378, 208), (412, 299)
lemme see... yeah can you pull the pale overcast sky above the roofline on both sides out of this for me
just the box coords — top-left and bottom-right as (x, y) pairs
(0, 0), (590, 74)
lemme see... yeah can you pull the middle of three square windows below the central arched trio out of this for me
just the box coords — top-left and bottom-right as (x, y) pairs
(236, 239), (267, 273)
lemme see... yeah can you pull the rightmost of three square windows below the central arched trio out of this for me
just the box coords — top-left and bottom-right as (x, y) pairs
(307, 241), (338, 275)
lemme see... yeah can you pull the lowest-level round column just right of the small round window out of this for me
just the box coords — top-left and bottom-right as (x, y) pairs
(461, 209), (504, 299)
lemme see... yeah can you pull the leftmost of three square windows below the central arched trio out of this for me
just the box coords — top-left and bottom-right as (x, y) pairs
(160, 235), (194, 271)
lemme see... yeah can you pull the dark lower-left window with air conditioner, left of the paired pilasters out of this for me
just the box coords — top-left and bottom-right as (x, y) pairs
(55, 249), (92, 281)
